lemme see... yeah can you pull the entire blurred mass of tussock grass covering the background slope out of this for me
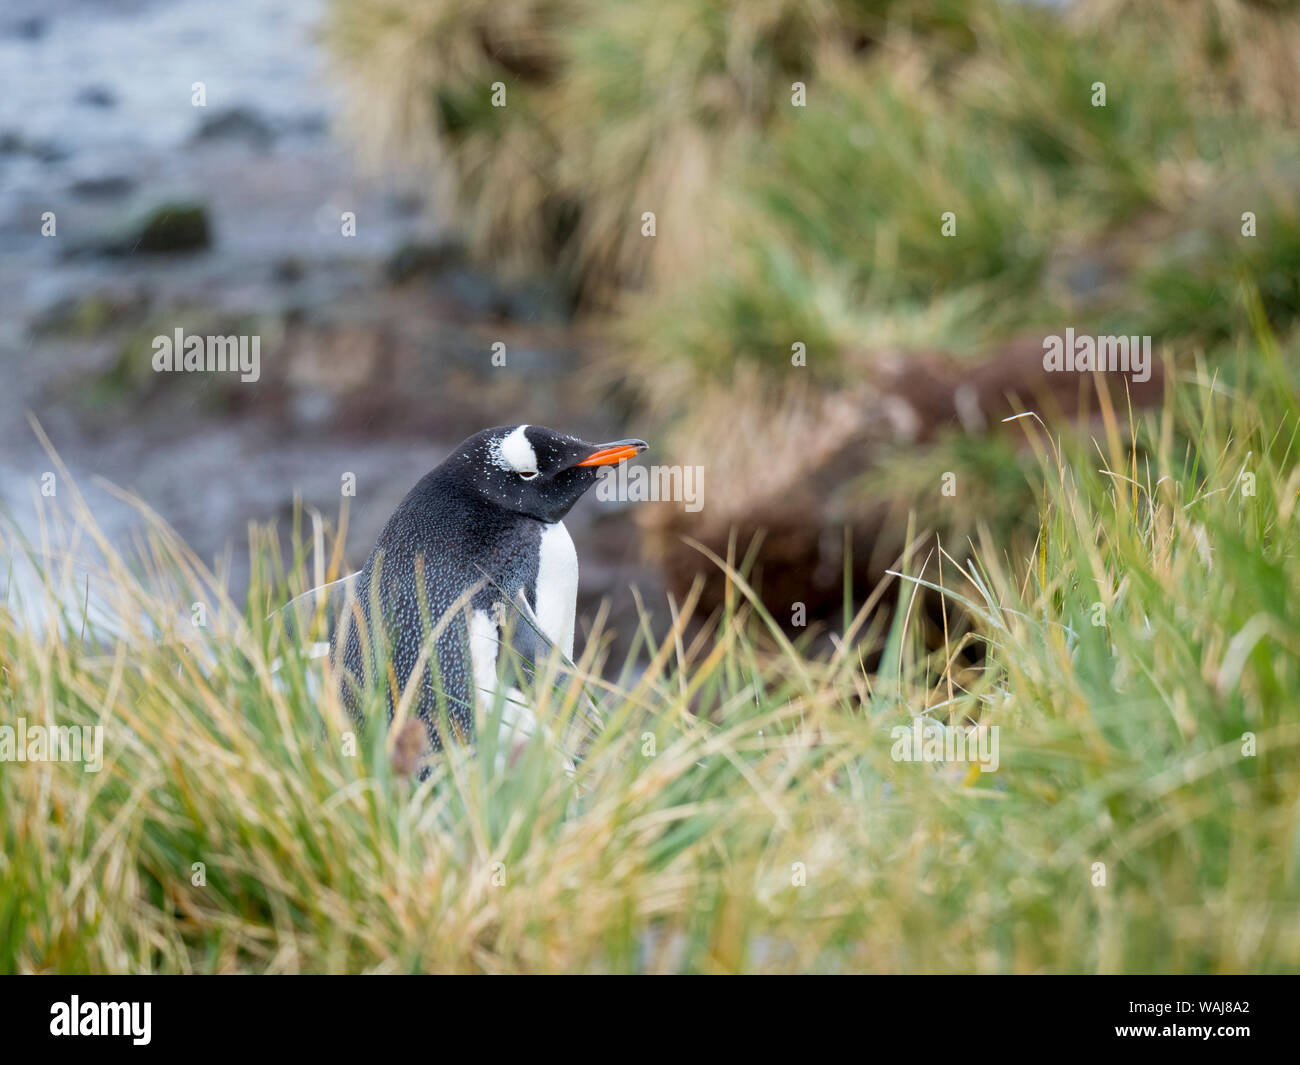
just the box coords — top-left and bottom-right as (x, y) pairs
(328, 0), (1300, 343)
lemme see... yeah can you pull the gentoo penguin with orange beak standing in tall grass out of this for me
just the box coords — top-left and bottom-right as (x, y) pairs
(330, 425), (647, 750)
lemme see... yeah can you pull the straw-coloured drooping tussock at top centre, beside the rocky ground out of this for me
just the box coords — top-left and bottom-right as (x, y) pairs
(326, 0), (852, 304)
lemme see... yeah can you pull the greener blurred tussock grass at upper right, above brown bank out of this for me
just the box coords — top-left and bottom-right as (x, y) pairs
(619, 3), (1300, 392)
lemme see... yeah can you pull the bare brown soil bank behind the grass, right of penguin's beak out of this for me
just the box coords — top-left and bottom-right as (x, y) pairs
(641, 338), (1165, 624)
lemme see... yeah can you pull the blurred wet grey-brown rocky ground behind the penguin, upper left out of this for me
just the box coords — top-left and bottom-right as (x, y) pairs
(0, 0), (655, 637)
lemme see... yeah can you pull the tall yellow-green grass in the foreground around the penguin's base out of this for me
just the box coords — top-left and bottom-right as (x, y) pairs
(0, 351), (1300, 971)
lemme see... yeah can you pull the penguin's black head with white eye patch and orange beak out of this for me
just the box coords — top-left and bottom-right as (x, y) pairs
(443, 425), (649, 521)
